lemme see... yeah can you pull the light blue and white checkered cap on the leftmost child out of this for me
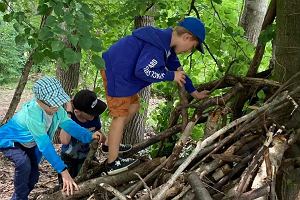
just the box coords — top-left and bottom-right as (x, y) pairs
(32, 76), (70, 107)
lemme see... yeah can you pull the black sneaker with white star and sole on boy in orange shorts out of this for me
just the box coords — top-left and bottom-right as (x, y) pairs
(106, 157), (139, 175)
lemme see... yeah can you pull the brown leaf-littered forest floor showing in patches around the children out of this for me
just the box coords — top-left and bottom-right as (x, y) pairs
(0, 87), (160, 200)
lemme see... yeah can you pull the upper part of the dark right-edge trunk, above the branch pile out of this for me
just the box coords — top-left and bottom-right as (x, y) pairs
(274, 0), (300, 83)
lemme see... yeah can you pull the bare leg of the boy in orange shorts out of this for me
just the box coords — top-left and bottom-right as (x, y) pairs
(107, 104), (140, 163)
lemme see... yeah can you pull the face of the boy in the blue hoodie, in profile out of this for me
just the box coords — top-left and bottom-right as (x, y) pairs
(174, 33), (198, 54)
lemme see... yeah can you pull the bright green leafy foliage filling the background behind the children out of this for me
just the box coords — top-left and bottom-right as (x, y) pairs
(0, 0), (276, 155)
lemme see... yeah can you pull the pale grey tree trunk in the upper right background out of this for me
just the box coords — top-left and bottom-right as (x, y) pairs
(240, 0), (268, 45)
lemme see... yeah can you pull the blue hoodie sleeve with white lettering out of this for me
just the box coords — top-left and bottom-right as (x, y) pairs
(135, 44), (174, 83)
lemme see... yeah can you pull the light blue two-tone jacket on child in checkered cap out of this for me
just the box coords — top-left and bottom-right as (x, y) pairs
(0, 99), (92, 173)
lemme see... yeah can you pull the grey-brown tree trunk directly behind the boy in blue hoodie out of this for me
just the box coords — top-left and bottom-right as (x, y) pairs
(122, 16), (154, 144)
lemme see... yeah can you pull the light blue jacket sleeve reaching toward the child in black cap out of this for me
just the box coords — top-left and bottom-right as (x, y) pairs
(59, 111), (93, 143)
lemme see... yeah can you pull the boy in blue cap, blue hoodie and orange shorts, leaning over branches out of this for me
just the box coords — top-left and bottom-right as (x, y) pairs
(101, 17), (208, 175)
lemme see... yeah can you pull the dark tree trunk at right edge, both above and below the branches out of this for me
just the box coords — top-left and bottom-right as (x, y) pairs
(273, 0), (300, 200)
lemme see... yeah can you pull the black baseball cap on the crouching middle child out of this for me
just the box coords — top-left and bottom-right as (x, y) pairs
(72, 89), (107, 116)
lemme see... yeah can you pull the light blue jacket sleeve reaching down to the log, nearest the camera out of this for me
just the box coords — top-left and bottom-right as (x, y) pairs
(28, 119), (66, 173)
